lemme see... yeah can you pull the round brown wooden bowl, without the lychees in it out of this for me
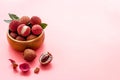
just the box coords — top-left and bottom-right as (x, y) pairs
(7, 31), (45, 51)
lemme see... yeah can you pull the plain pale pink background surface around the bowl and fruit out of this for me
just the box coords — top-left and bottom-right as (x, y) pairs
(0, 0), (120, 80)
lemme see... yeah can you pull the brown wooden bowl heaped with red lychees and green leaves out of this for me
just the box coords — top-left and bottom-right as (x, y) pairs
(4, 13), (47, 51)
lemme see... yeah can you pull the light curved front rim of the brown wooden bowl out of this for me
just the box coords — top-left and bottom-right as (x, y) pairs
(7, 30), (44, 43)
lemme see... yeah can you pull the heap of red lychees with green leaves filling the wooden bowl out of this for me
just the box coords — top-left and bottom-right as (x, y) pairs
(4, 14), (47, 41)
